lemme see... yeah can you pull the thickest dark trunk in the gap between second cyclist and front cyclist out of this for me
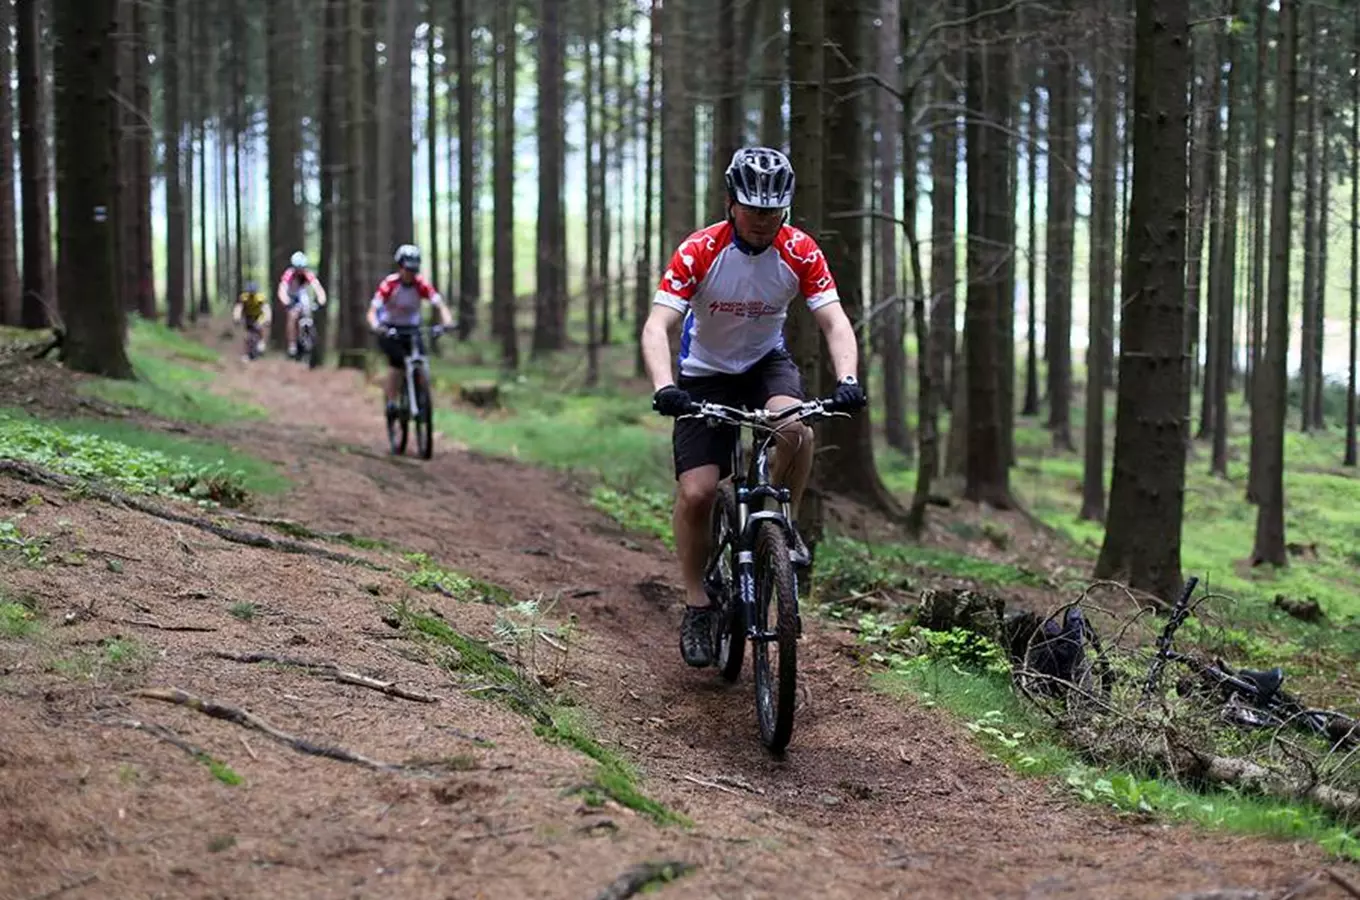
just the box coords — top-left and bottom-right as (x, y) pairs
(532, 0), (567, 358)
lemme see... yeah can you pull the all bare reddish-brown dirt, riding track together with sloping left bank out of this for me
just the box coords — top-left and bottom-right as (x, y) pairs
(0, 339), (1345, 899)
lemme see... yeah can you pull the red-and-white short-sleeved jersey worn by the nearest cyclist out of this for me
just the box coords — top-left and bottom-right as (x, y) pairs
(653, 222), (840, 375)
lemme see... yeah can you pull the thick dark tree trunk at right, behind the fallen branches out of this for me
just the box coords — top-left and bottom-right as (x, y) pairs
(1095, 0), (1190, 604)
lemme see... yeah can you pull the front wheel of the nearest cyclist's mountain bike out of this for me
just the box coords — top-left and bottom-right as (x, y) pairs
(752, 522), (798, 753)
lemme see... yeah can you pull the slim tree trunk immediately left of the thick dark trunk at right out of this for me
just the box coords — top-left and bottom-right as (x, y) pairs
(1081, 0), (1119, 522)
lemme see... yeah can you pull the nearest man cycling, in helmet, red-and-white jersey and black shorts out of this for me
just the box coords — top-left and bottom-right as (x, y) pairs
(642, 147), (866, 666)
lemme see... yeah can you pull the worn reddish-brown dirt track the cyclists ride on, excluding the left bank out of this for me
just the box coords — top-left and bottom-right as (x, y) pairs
(197, 360), (1344, 897)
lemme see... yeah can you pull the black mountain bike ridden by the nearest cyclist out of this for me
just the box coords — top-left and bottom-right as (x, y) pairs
(679, 398), (850, 753)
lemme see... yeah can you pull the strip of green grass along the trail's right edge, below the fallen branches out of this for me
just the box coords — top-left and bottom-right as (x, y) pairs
(873, 658), (1360, 859)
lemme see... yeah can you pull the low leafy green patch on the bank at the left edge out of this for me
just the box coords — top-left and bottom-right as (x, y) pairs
(0, 409), (278, 506)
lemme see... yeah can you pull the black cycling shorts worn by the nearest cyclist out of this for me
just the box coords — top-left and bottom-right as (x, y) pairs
(670, 349), (804, 479)
